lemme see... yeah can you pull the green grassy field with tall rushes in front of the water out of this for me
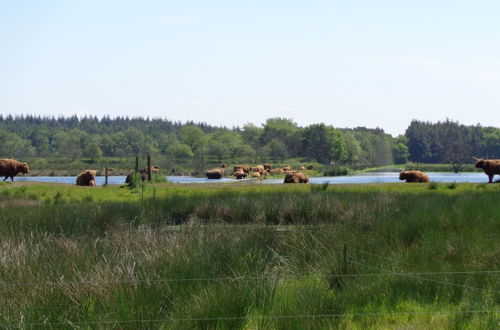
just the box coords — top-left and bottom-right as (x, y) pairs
(0, 183), (500, 329)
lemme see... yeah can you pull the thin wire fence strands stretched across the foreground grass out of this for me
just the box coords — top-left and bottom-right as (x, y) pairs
(0, 247), (500, 327)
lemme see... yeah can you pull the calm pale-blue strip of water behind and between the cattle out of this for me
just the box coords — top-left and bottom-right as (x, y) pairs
(14, 172), (490, 185)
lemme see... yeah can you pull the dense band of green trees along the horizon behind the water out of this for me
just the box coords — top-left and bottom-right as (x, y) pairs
(0, 115), (500, 167)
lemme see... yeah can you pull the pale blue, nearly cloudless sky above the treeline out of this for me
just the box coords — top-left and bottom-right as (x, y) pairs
(0, 0), (500, 135)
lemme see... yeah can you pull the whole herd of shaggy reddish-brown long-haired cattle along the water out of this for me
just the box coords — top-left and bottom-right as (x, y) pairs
(0, 158), (500, 186)
